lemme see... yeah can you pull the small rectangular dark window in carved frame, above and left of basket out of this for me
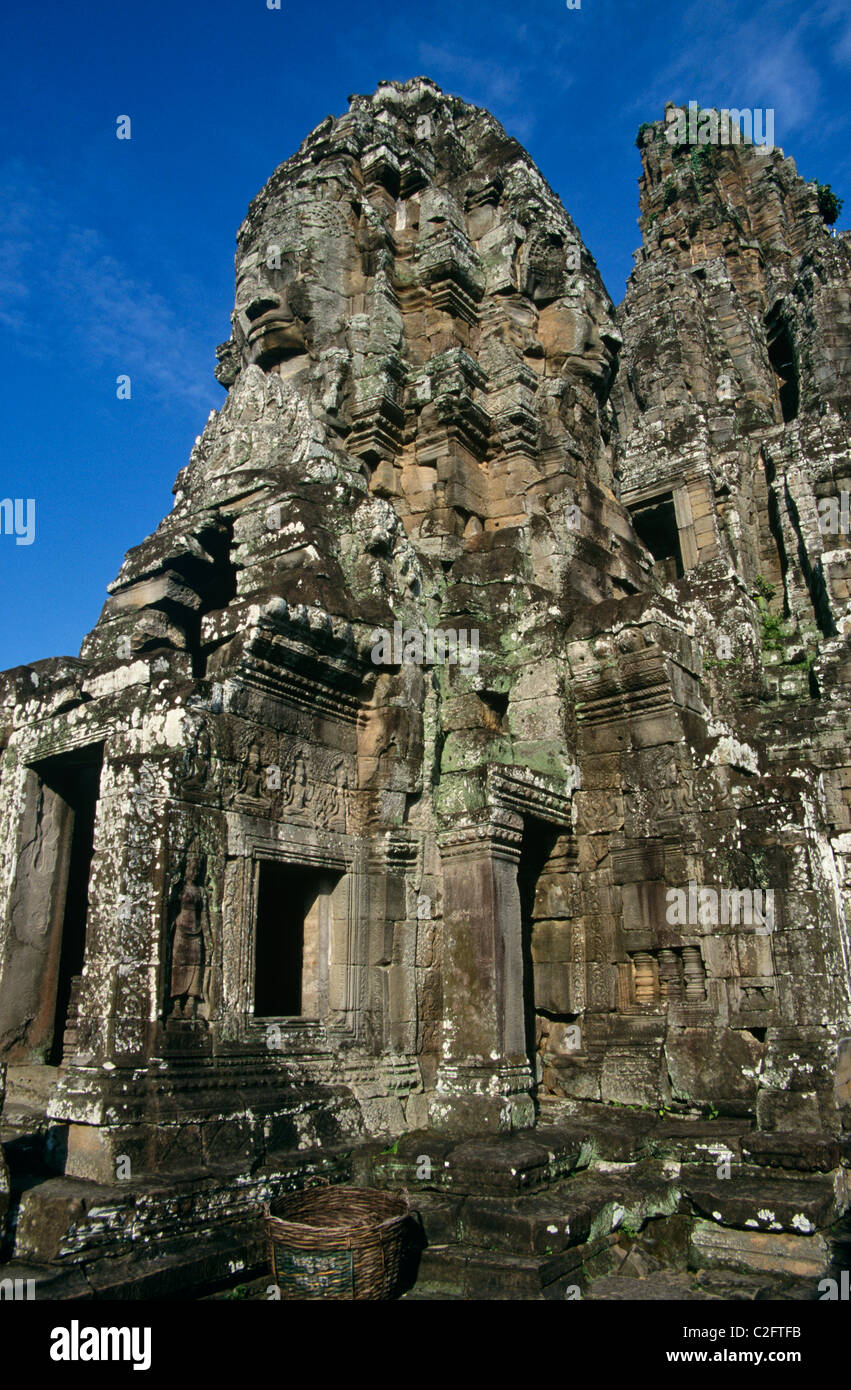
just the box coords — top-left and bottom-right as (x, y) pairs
(254, 860), (328, 1019)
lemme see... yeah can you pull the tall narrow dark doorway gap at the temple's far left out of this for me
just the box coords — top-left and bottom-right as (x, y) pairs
(38, 744), (103, 1066)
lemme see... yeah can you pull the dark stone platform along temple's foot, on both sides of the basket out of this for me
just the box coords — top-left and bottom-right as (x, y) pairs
(0, 1105), (851, 1301)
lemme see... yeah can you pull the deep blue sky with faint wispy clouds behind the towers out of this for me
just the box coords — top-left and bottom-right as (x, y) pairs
(0, 0), (851, 669)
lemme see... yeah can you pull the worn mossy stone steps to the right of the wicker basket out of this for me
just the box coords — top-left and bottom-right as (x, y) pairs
(355, 1106), (848, 1300)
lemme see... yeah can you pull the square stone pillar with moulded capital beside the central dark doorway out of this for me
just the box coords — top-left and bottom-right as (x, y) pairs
(431, 812), (534, 1130)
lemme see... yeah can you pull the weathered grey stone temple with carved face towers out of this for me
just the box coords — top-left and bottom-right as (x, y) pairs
(0, 78), (851, 1289)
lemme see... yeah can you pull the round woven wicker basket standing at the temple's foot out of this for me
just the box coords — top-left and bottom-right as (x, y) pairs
(264, 1187), (410, 1298)
